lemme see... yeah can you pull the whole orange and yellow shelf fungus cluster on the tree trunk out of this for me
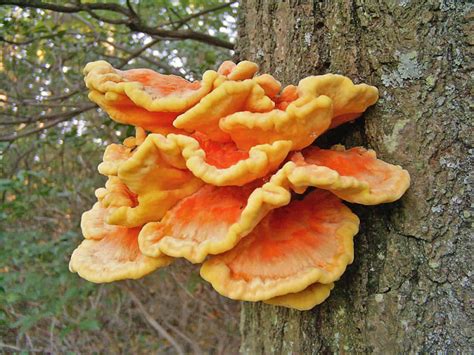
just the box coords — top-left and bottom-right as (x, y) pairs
(70, 61), (410, 310)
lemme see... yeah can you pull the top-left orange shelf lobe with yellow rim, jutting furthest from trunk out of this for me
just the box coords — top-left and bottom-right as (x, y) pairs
(84, 61), (219, 134)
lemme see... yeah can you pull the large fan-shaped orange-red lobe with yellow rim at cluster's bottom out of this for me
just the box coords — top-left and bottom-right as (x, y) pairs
(201, 190), (359, 301)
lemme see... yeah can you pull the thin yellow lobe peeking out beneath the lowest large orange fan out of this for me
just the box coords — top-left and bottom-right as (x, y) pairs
(263, 282), (334, 311)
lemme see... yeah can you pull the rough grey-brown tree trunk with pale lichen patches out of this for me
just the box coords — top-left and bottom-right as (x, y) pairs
(236, 0), (474, 354)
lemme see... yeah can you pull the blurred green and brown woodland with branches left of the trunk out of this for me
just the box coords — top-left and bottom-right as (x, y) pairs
(0, 0), (240, 354)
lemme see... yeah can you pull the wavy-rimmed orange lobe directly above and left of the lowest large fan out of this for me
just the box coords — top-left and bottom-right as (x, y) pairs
(139, 179), (291, 263)
